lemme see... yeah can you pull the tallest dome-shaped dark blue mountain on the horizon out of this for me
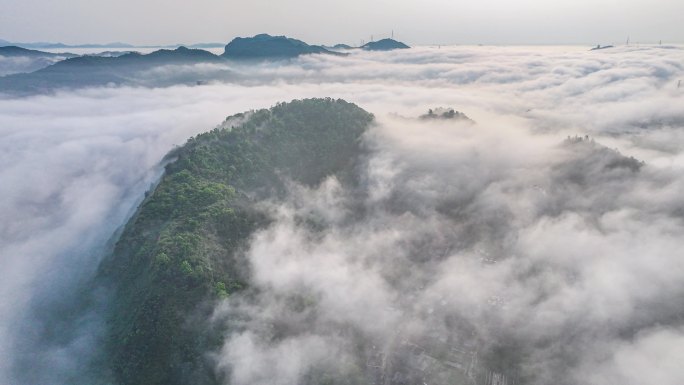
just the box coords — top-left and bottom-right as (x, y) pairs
(221, 34), (340, 60)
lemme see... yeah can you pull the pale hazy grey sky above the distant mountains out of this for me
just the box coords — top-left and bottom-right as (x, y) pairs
(0, 0), (684, 45)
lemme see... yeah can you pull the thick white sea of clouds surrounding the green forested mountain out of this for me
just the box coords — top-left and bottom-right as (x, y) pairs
(0, 46), (684, 385)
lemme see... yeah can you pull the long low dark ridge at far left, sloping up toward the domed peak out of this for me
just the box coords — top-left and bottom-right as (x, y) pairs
(0, 47), (223, 95)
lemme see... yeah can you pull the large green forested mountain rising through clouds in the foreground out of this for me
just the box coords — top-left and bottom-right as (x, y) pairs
(91, 99), (373, 385)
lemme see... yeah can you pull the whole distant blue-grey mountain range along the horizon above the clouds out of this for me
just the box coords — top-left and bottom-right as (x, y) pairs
(0, 34), (408, 95)
